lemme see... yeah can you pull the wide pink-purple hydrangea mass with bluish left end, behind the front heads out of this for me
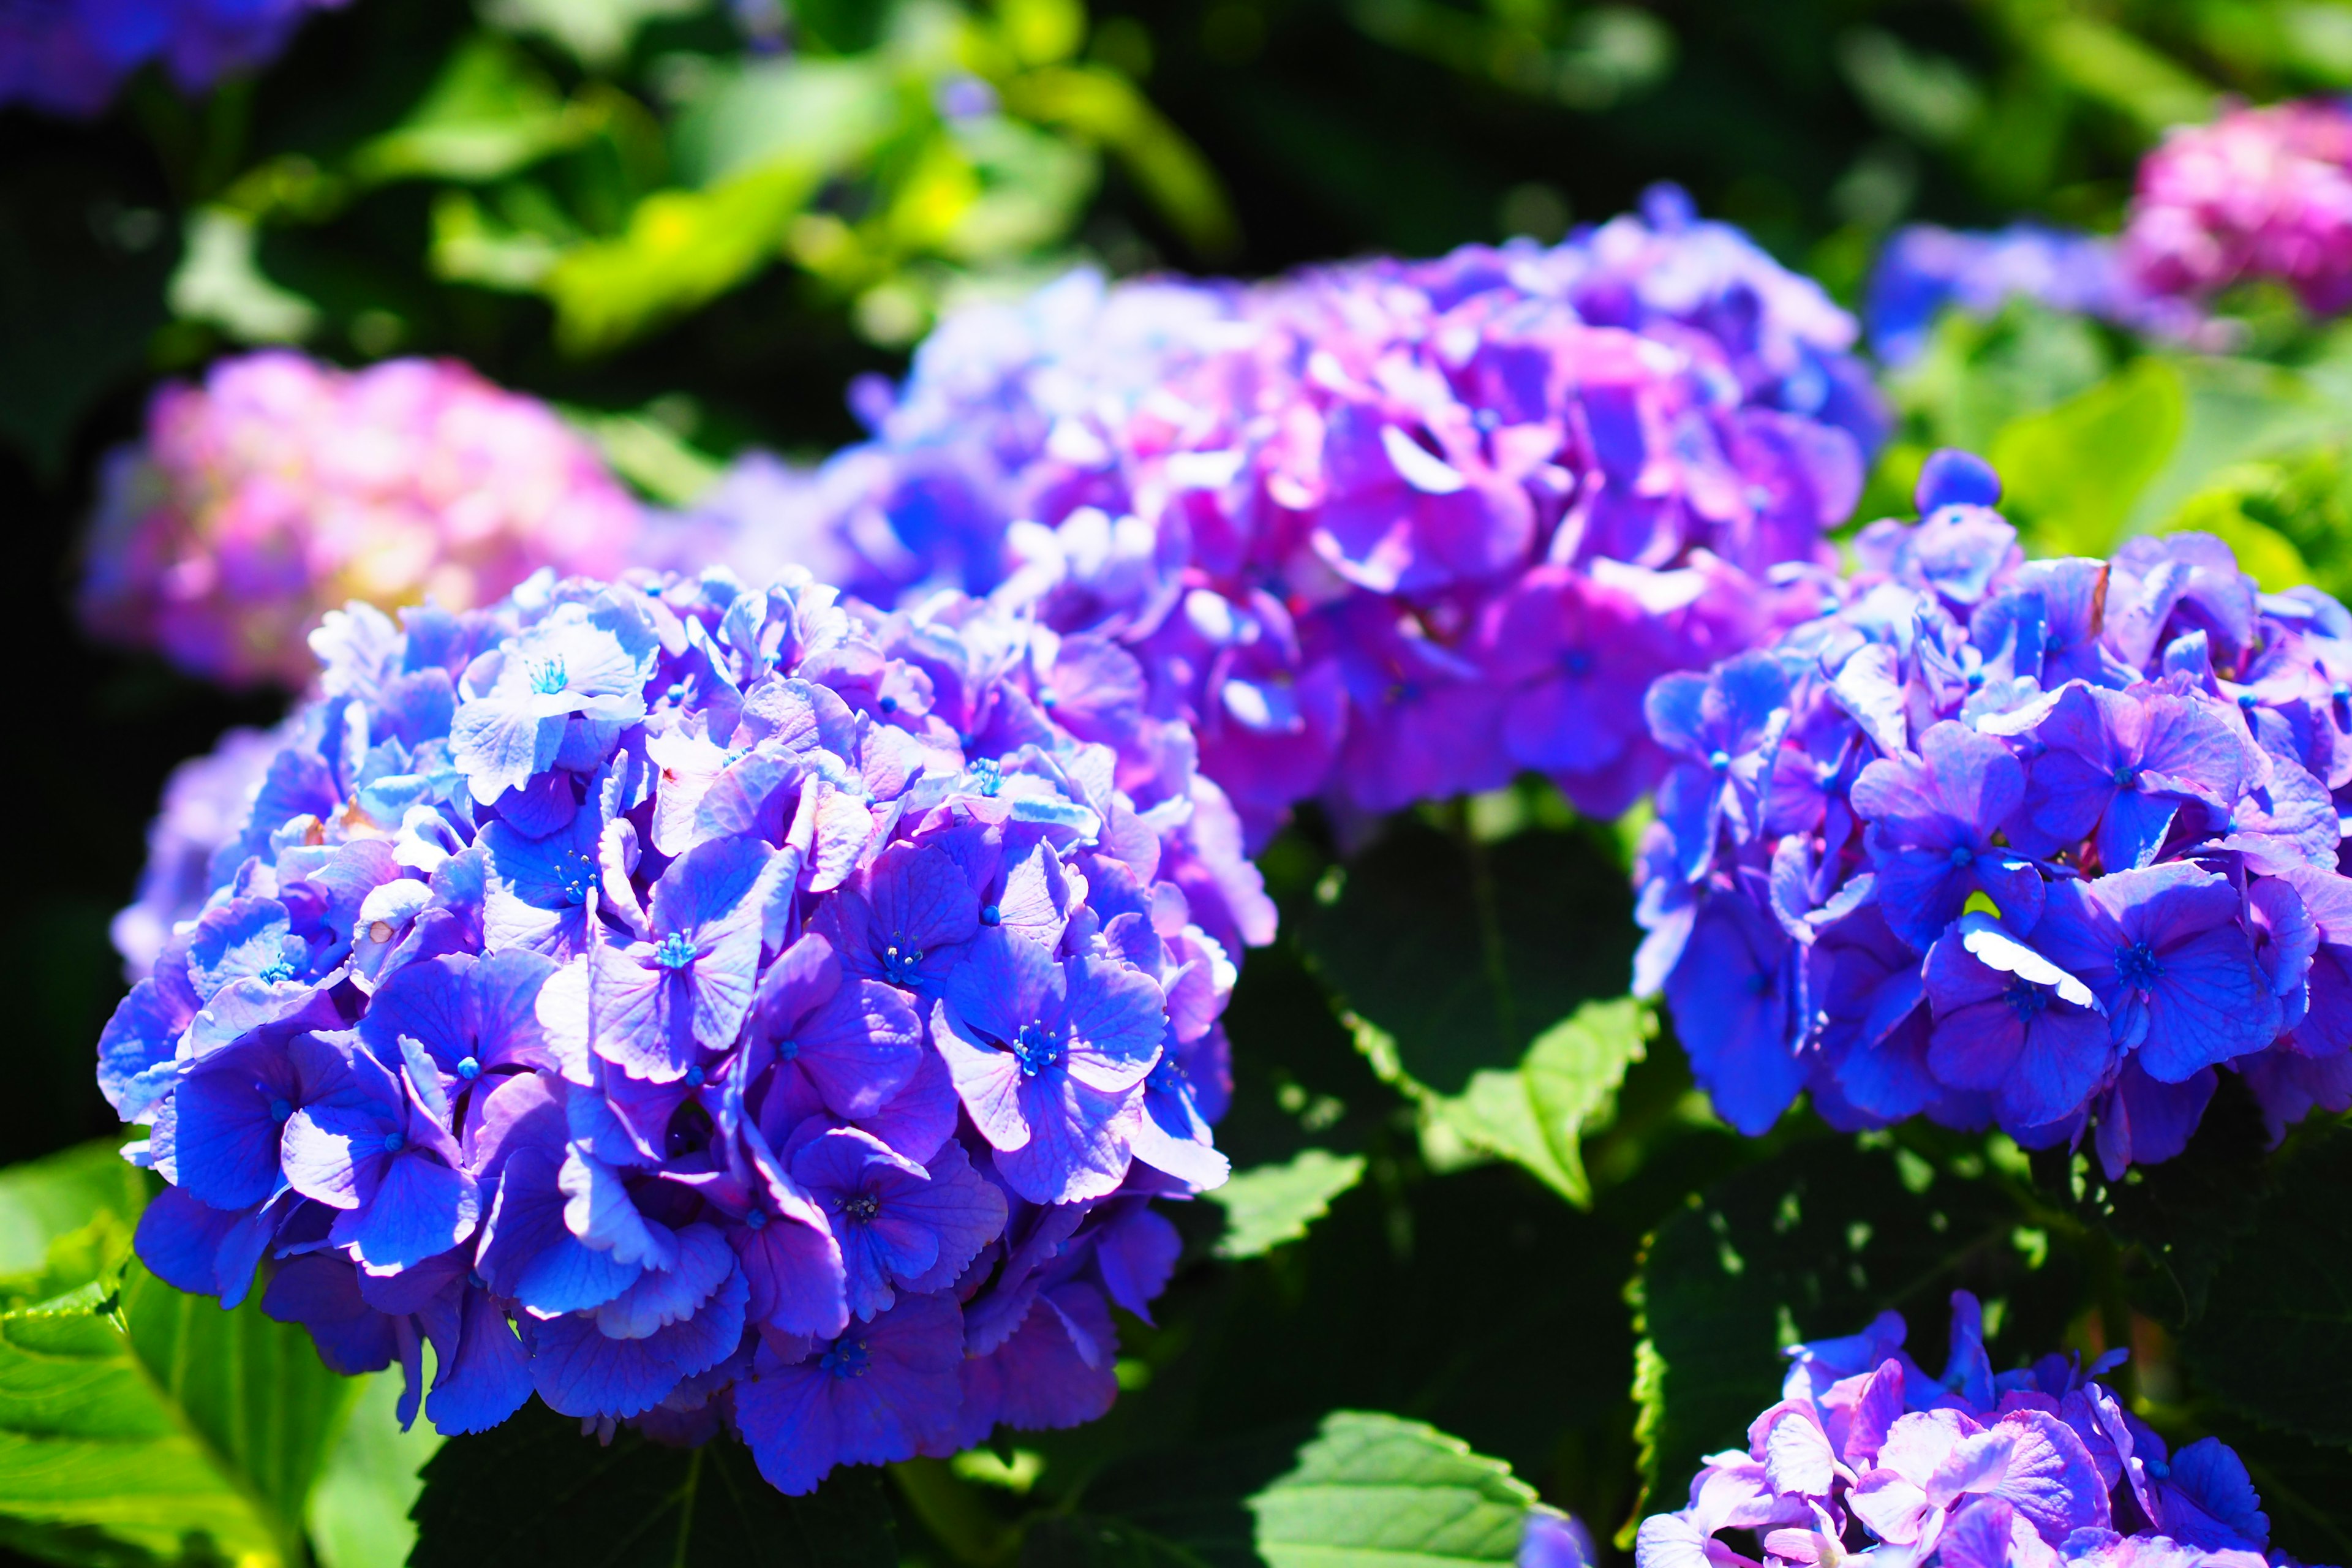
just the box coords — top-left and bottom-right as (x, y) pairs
(687, 188), (1884, 842)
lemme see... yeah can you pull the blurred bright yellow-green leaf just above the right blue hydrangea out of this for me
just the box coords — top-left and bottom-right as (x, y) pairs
(1988, 360), (2187, 555)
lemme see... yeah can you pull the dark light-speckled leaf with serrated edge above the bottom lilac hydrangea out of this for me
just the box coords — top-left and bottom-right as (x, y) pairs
(1637, 1140), (2075, 1498)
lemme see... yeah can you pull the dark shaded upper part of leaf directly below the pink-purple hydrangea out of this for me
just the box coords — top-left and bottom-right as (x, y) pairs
(1301, 818), (1639, 1096)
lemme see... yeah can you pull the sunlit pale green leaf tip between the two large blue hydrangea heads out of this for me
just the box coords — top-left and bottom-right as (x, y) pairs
(1420, 997), (1658, 1206)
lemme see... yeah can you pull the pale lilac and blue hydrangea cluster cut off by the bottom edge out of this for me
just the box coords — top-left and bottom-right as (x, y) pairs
(1635, 1291), (2284, 1568)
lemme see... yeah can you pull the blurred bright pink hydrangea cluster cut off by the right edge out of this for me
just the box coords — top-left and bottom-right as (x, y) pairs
(2124, 99), (2352, 315)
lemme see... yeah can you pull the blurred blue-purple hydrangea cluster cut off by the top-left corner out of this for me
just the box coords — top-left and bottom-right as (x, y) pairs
(0, 0), (344, 115)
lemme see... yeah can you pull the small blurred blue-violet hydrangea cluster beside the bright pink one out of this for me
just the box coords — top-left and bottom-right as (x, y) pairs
(1863, 224), (2218, 364)
